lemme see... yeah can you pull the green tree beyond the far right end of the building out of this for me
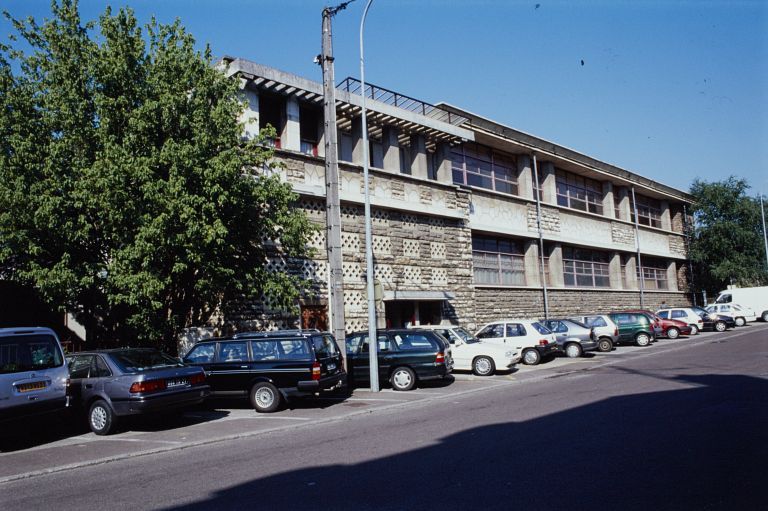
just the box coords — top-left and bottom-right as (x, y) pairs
(691, 176), (768, 293)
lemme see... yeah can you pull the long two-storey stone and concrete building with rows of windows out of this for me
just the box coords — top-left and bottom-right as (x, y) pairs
(224, 58), (691, 331)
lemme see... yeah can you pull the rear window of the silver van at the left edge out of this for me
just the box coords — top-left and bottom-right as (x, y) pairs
(0, 334), (64, 374)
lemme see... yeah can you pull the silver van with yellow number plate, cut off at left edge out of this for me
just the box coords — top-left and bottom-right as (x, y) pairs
(0, 327), (69, 423)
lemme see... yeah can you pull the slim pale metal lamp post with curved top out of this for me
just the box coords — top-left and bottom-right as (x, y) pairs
(360, 0), (380, 392)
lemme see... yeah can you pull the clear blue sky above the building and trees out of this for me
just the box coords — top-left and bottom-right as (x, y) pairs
(0, 0), (768, 195)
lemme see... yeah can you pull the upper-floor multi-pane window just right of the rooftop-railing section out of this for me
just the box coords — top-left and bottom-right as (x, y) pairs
(451, 144), (517, 195)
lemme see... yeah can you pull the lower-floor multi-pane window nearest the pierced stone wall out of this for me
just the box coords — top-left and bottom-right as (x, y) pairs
(472, 235), (525, 286)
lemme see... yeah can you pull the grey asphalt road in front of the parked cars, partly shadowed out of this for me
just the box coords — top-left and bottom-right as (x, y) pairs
(0, 324), (768, 511)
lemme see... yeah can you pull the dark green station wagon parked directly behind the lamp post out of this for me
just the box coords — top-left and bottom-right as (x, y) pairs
(346, 329), (453, 391)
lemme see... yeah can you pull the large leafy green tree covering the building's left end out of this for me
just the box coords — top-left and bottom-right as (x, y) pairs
(0, 0), (311, 347)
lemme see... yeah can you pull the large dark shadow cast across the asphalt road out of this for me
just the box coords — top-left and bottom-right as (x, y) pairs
(160, 376), (768, 511)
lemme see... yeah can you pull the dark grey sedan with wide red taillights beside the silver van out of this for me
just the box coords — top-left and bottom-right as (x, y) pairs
(67, 348), (210, 435)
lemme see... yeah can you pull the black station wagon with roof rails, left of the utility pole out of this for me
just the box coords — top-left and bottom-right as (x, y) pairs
(184, 330), (346, 412)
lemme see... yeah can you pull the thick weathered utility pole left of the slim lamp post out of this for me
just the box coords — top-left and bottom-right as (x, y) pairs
(319, 2), (349, 363)
